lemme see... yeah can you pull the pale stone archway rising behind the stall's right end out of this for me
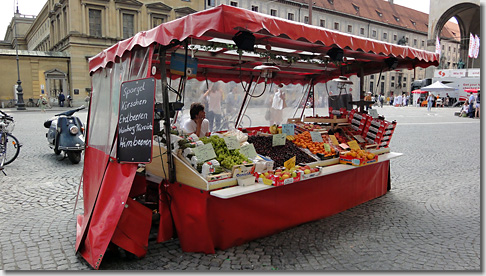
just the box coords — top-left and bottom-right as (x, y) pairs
(428, 0), (481, 68)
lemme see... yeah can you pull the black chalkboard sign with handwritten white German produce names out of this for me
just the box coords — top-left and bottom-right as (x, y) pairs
(117, 78), (155, 163)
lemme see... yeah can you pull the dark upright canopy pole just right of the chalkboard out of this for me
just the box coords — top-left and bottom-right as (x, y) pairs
(159, 48), (176, 183)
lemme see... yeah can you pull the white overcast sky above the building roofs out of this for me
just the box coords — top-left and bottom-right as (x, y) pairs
(0, 0), (468, 40)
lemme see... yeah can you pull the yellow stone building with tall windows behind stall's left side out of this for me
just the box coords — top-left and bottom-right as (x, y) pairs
(0, 0), (204, 106)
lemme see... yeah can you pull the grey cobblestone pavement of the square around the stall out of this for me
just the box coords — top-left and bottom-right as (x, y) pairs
(0, 106), (481, 272)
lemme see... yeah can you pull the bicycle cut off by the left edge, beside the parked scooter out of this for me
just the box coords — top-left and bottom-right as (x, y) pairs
(0, 110), (22, 175)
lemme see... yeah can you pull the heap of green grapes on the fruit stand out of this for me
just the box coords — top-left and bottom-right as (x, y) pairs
(200, 135), (251, 170)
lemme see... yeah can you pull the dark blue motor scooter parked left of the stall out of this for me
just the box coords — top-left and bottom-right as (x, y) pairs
(44, 105), (85, 164)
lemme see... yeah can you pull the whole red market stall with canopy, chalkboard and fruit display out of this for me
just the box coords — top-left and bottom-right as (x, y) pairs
(76, 5), (438, 269)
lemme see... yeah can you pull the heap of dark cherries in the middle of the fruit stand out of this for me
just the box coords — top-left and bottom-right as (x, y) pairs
(248, 136), (316, 167)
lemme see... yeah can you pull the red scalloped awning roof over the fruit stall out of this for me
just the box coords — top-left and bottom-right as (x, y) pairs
(89, 5), (438, 83)
